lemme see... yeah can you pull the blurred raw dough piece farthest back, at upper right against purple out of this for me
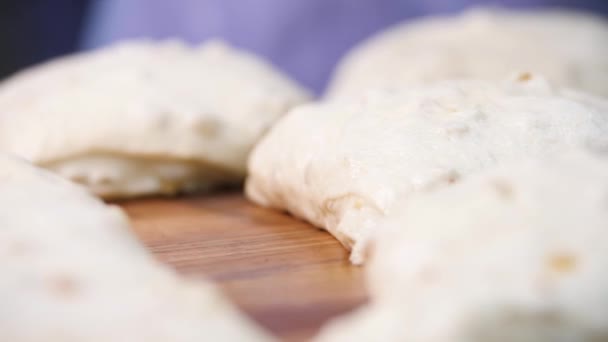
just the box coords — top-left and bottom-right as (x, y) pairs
(329, 9), (608, 98)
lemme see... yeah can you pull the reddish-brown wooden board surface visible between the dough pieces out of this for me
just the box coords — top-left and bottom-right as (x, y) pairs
(121, 193), (366, 341)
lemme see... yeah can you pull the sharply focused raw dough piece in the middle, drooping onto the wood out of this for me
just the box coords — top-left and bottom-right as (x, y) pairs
(246, 75), (608, 263)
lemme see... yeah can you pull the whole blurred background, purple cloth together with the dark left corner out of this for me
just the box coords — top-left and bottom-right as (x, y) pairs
(0, 0), (608, 93)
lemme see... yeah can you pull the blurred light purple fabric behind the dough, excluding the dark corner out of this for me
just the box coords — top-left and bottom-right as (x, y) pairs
(83, 0), (608, 92)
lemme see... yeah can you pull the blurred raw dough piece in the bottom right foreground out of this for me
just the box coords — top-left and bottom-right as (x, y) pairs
(317, 153), (608, 342)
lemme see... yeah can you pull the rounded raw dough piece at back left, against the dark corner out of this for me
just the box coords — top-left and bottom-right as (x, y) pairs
(0, 41), (307, 198)
